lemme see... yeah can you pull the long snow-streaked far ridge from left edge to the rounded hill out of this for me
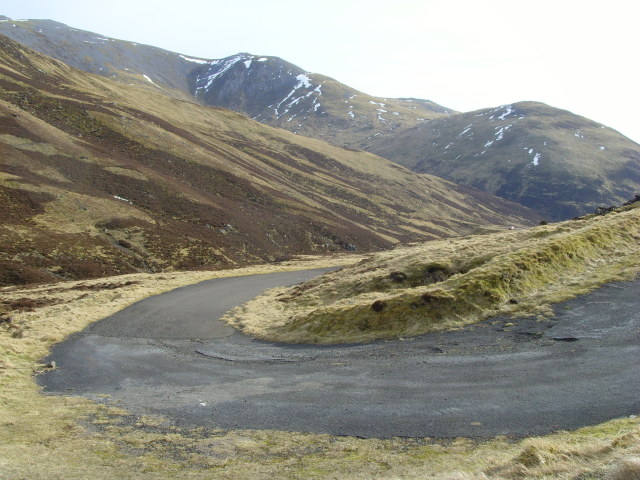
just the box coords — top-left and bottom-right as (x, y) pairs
(0, 17), (450, 148)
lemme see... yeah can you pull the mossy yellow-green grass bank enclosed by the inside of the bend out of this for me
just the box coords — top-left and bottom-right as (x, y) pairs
(227, 207), (640, 343)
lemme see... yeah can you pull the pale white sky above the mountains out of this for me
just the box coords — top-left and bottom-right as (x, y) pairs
(0, 0), (640, 142)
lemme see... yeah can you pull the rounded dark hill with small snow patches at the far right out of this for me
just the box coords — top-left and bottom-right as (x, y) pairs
(369, 102), (640, 220)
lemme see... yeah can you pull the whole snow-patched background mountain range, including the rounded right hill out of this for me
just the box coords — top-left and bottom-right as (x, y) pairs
(0, 19), (640, 220)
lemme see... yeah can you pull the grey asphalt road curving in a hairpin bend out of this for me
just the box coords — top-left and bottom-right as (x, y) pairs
(38, 271), (640, 438)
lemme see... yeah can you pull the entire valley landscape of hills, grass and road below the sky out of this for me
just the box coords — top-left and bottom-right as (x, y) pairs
(0, 16), (640, 480)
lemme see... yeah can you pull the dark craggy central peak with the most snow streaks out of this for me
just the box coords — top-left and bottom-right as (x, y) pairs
(189, 53), (450, 148)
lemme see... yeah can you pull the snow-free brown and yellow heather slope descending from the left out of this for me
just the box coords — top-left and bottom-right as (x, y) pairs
(0, 36), (536, 284)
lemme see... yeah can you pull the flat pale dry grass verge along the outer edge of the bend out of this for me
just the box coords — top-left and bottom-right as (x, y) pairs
(0, 249), (640, 480)
